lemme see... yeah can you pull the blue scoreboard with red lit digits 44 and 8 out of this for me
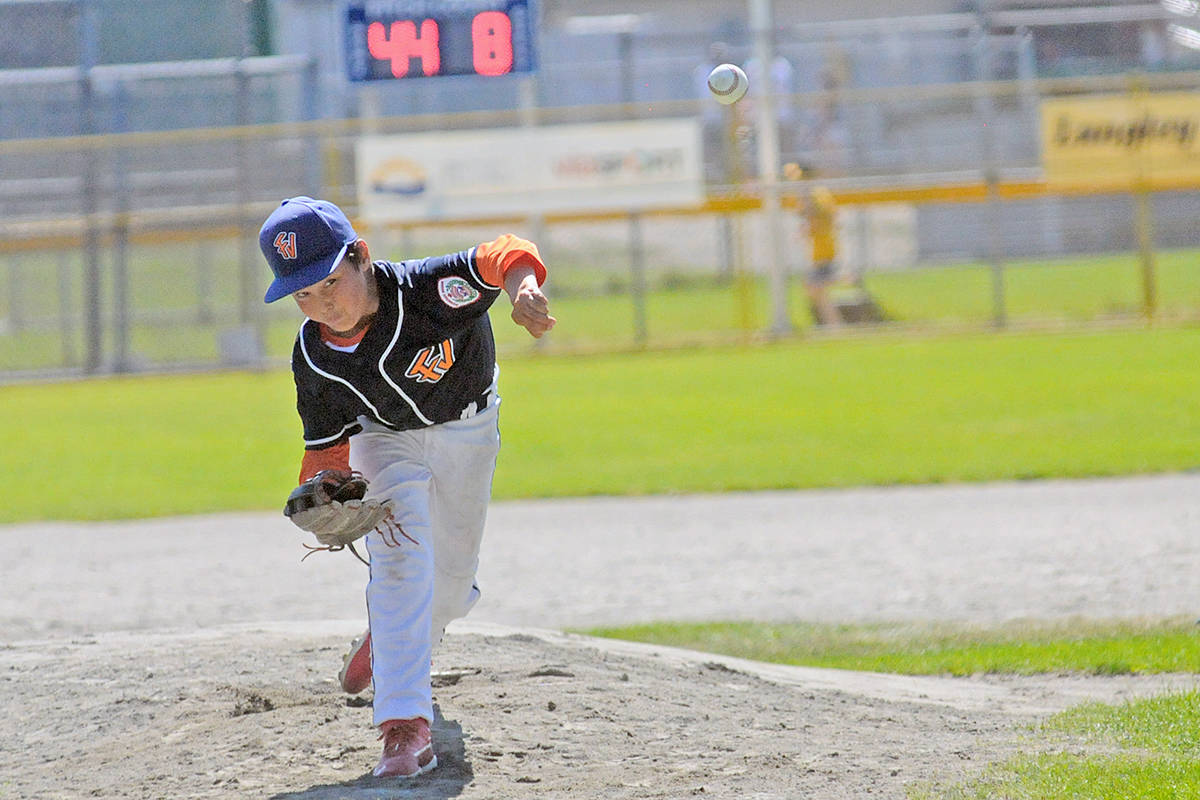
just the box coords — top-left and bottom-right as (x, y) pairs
(346, 0), (535, 80)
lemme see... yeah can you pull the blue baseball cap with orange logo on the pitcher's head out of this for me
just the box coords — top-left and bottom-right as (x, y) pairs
(258, 197), (359, 302)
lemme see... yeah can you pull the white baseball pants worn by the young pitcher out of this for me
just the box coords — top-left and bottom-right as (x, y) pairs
(350, 393), (500, 726)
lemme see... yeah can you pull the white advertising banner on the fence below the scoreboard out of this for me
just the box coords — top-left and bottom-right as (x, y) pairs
(356, 120), (704, 223)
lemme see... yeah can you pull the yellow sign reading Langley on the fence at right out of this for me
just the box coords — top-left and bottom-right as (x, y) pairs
(1042, 92), (1200, 186)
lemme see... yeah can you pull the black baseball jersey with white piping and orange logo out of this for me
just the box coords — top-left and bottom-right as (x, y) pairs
(292, 247), (500, 450)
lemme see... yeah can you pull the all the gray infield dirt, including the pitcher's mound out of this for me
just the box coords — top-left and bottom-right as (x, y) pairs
(0, 475), (1200, 800)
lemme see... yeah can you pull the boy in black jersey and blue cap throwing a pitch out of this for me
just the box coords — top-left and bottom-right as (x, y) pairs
(259, 197), (556, 777)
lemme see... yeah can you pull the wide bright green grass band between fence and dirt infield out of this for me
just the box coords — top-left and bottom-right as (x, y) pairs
(0, 327), (1200, 523)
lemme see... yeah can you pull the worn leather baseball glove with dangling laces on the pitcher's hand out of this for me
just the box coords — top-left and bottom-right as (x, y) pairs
(283, 469), (412, 558)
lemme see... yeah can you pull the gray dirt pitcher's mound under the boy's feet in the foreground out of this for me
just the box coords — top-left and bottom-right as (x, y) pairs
(0, 622), (1194, 800)
